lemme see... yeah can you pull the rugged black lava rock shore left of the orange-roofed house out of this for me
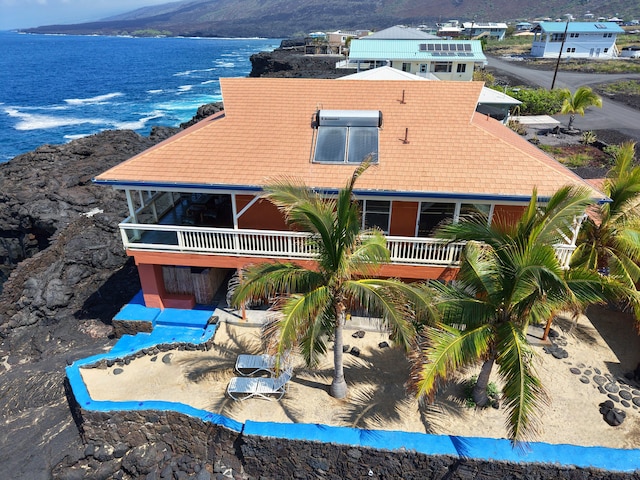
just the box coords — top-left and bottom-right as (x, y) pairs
(0, 104), (221, 479)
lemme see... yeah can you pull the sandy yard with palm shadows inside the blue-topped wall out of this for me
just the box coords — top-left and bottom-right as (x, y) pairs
(81, 307), (640, 448)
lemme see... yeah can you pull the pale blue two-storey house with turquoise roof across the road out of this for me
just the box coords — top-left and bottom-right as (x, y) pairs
(531, 22), (624, 58)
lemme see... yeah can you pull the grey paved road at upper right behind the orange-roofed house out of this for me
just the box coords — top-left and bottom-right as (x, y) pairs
(487, 57), (640, 142)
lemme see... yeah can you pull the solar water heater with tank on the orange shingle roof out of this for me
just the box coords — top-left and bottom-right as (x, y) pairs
(313, 110), (382, 163)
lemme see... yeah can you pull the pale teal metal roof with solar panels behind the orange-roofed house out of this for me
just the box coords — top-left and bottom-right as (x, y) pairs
(349, 39), (487, 62)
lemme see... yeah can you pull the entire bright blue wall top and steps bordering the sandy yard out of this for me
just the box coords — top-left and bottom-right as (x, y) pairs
(66, 295), (640, 472)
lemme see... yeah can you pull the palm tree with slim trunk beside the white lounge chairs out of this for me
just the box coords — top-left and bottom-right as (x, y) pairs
(232, 162), (415, 398)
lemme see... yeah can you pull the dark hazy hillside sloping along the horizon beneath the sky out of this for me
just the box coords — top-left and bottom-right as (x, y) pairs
(25, 0), (640, 38)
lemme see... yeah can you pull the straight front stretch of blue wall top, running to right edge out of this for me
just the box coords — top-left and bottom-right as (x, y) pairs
(242, 420), (640, 472)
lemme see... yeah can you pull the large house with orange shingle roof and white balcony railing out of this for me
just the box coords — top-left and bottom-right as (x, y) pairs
(94, 78), (606, 308)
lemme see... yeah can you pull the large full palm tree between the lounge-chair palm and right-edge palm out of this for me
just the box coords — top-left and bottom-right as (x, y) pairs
(410, 187), (608, 443)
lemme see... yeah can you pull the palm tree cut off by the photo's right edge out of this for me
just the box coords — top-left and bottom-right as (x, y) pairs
(571, 142), (640, 318)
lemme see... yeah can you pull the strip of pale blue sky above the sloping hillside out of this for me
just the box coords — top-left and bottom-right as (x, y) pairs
(0, 0), (175, 30)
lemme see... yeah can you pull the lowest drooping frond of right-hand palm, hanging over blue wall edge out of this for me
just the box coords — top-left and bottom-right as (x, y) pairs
(496, 323), (548, 444)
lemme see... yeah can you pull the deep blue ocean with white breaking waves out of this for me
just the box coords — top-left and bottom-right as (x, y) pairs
(0, 32), (280, 162)
